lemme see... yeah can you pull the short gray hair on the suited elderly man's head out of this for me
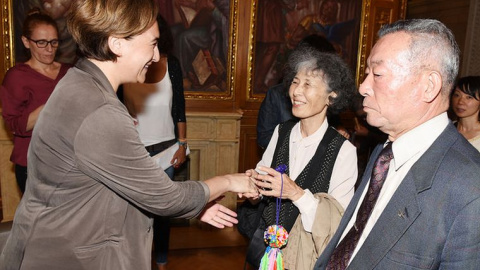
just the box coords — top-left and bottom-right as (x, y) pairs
(378, 19), (460, 97)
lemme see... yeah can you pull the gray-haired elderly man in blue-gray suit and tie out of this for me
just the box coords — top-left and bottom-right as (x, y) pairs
(315, 19), (480, 270)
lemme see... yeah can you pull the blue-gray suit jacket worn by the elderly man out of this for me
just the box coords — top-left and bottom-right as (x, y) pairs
(314, 124), (480, 270)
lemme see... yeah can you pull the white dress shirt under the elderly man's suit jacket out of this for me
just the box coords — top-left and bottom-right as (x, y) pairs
(339, 113), (449, 261)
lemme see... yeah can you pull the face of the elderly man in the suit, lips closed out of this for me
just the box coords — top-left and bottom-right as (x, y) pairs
(359, 32), (422, 139)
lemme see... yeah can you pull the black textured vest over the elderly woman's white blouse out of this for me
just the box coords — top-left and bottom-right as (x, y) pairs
(260, 121), (346, 231)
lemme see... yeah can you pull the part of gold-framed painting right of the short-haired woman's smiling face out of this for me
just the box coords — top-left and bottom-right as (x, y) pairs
(157, 0), (238, 100)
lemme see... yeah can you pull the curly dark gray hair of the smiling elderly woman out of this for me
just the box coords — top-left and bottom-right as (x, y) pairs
(284, 46), (356, 114)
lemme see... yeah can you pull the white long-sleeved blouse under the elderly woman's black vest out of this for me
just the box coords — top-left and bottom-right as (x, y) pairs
(257, 119), (358, 232)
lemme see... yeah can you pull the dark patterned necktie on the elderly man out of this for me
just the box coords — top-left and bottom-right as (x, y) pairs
(327, 142), (393, 270)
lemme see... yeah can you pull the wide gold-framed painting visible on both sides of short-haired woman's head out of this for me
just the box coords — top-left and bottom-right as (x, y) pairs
(13, 0), (238, 99)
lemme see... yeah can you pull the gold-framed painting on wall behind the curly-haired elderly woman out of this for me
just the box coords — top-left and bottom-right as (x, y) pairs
(247, 0), (365, 101)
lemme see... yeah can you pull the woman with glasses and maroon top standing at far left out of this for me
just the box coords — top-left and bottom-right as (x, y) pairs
(0, 8), (70, 193)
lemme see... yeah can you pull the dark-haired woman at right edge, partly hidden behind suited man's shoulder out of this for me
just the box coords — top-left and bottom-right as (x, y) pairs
(451, 76), (480, 151)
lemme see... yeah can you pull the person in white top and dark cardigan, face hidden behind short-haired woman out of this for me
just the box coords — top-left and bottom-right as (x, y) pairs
(121, 15), (187, 270)
